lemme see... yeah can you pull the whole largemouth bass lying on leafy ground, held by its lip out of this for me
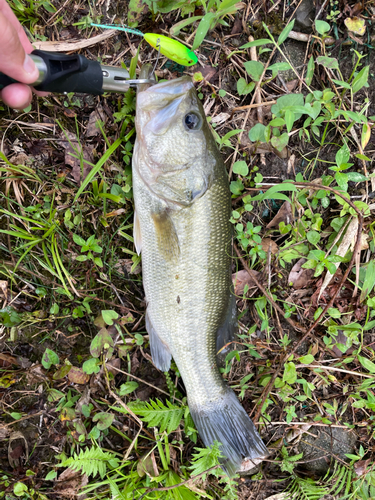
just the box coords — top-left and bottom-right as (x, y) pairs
(133, 73), (267, 475)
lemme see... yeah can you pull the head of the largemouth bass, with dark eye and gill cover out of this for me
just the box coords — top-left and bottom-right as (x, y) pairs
(133, 77), (216, 205)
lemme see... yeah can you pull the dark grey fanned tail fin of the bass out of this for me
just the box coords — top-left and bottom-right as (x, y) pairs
(189, 389), (268, 476)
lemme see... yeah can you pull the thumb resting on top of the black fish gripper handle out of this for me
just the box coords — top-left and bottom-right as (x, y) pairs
(0, 11), (39, 83)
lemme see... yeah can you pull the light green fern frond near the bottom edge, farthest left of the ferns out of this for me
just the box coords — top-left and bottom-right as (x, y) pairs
(59, 447), (119, 479)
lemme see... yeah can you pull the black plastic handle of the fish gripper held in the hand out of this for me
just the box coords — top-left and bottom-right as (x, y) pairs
(0, 50), (103, 95)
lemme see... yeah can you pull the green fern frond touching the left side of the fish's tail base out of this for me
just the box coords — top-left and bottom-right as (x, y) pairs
(112, 399), (186, 434)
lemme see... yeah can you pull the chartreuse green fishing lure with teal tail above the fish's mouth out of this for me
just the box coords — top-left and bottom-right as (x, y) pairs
(91, 23), (198, 66)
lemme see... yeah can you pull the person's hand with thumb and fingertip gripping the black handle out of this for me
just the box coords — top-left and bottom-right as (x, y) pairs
(0, 0), (39, 109)
